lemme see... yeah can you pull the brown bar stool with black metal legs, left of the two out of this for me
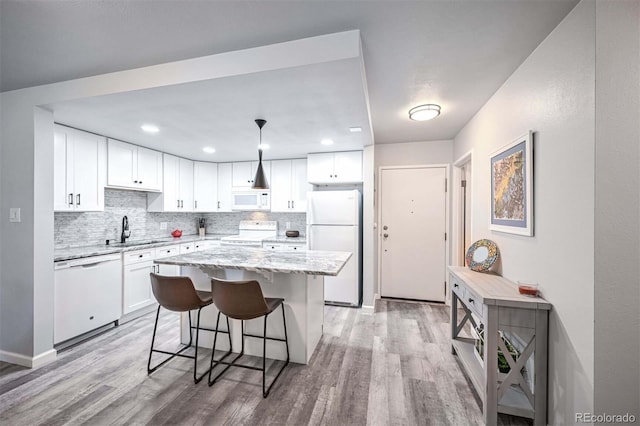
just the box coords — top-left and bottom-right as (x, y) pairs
(147, 273), (232, 383)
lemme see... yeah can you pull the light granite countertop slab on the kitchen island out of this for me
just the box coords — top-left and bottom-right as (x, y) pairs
(155, 246), (352, 276)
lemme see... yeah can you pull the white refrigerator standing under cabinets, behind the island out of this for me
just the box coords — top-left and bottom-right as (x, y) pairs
(307, 190), (362, 306)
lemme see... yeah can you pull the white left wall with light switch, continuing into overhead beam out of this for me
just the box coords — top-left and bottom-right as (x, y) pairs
(0, 31), (361, 366)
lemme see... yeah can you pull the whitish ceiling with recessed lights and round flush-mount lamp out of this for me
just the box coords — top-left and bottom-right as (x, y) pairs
(0, 0), (577, 161)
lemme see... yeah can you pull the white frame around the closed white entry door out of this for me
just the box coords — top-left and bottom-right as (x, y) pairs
(375, 164), (451, 305)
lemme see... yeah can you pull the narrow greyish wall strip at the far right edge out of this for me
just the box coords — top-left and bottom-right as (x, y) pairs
(594, 0), (640, 419)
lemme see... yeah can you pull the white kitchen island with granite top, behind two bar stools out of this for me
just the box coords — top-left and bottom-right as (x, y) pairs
(155, 246), (351, 364)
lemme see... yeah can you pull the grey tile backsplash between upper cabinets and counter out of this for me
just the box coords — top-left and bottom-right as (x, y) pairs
(54, 189), (307, 248)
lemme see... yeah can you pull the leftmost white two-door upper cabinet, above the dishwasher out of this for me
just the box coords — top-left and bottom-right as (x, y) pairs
(53, 124), (107, 211)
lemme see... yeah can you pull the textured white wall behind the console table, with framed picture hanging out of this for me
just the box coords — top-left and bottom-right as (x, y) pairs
(454, 0), (595, 424)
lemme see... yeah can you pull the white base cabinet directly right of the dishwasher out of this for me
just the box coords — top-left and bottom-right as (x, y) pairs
(122, 248), (156, 315)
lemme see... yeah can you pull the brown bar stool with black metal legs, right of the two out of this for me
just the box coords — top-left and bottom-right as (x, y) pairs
(209, 278), (289, 398)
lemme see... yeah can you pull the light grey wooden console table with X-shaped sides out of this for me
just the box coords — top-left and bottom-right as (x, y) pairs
(449, 266), (551, 425)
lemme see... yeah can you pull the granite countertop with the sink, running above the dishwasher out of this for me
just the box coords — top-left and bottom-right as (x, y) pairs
(53, 234), (229, 262)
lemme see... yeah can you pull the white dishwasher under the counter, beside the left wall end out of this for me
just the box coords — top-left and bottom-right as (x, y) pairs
(53, 253), (122, 344)
